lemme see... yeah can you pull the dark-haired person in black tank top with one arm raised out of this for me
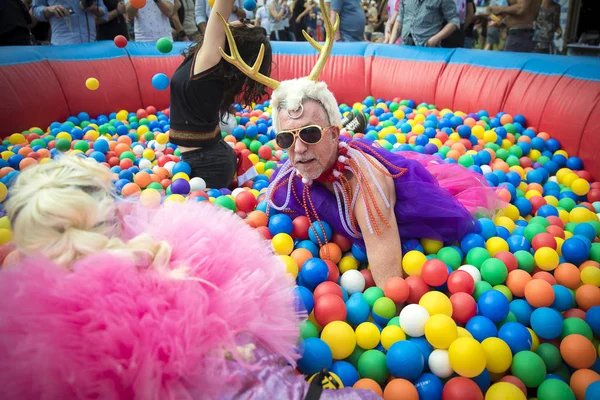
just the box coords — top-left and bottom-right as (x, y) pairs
(169, 0), (272, 189)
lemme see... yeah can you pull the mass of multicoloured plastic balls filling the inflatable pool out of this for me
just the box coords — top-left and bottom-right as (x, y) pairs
(0, 47), (600, 400)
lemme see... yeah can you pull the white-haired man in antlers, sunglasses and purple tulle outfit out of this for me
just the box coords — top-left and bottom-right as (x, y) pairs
(218, 0), (500, 286)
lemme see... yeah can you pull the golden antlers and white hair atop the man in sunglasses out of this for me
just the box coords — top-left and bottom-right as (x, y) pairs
(217, 0), (342, 131)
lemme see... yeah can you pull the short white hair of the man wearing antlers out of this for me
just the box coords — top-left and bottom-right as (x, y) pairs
(271, 78), (342, 132)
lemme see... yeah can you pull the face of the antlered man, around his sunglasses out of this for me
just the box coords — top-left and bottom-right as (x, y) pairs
(279, 100), (339, 179)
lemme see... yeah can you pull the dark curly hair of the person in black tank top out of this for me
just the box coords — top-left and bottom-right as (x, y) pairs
(183, 23), (272, 118)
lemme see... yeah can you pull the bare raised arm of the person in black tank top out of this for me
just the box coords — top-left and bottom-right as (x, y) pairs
(194, 0), (235, 75)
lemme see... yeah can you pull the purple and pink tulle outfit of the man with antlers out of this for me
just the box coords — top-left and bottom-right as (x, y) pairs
(272, 137), (503, 249)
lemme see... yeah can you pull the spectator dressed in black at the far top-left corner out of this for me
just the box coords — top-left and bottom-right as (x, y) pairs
(0, 0), (33, 46)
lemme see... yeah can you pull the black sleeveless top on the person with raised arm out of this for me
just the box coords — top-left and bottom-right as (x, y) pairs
(169, 57), (225, 147)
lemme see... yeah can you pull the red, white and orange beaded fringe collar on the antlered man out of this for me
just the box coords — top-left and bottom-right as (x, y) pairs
(266, 140), (406, 247)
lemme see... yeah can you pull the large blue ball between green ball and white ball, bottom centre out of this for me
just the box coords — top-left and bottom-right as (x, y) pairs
(386, 340), (425, 381)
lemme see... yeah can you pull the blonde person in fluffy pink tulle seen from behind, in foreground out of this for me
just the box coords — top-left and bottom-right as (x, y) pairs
(0, 156), (377, 400)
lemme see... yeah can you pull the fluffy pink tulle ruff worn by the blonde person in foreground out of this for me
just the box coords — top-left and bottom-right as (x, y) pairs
(0, 203), (300, 400)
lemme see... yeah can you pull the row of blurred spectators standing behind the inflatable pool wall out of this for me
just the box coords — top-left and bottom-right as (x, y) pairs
(0, 0), (562, 53)
